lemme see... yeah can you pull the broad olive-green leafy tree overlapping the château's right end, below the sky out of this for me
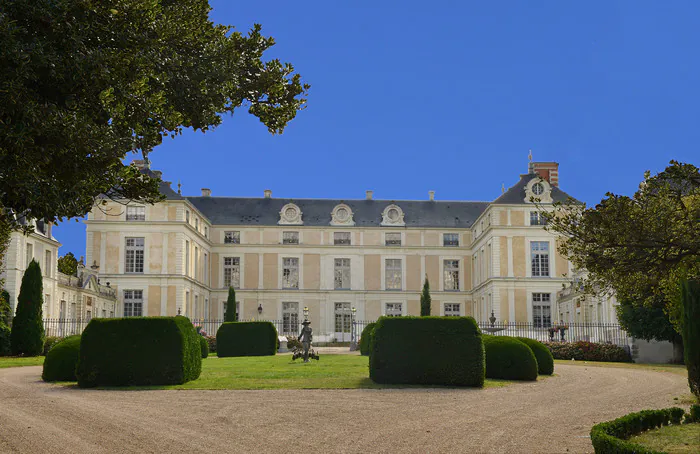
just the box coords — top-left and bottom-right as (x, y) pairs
(544, 161), (700, 332)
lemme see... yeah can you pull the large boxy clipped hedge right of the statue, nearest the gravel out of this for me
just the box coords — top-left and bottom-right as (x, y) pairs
(369, 317), (484, 387)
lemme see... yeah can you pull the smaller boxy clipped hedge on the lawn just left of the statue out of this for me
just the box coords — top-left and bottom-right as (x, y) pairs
(216, 322), (278, 358)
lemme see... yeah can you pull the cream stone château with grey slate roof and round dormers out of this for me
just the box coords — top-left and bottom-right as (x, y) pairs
(86, 161), (571, 339)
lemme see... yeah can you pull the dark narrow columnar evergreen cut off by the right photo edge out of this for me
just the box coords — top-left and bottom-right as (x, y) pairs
(681, 279), (700, 398)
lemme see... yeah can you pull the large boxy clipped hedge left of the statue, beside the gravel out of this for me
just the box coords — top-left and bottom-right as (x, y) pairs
(76, 316), (202, 388)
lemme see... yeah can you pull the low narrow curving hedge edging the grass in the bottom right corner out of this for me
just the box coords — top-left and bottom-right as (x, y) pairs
(591, 407), (690, 454)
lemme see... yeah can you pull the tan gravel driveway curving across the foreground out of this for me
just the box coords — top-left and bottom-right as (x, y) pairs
(0, 365), (687, 453)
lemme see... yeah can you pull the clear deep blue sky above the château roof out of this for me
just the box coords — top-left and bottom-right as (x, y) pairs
(55, 0), (700, 256)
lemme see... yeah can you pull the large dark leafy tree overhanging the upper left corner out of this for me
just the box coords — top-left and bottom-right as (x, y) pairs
(0, 0), (309, 228)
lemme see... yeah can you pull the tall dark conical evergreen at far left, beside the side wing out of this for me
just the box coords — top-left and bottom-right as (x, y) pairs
(10, 260), (44, 356)
